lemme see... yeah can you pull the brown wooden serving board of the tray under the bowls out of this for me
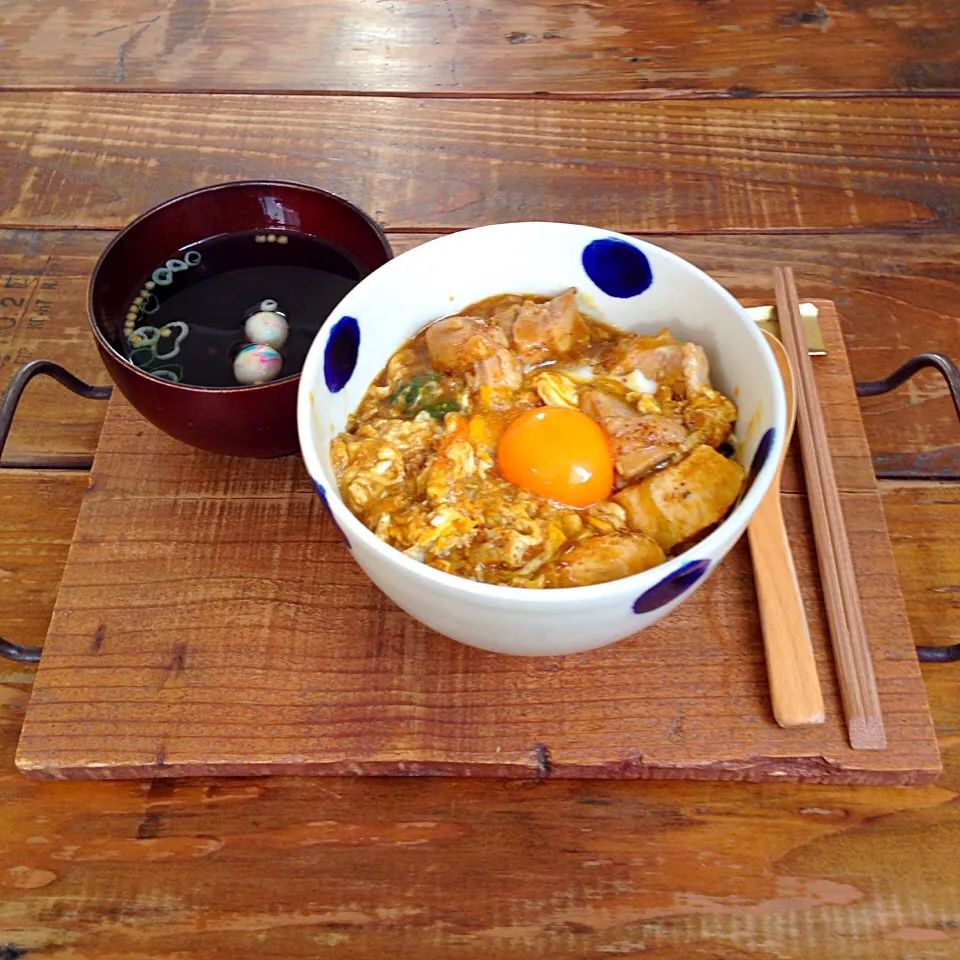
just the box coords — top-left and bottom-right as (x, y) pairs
(17, 302), (940, 783)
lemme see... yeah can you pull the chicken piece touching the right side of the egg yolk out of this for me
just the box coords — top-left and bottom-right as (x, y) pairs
(580, 388), (687, 480)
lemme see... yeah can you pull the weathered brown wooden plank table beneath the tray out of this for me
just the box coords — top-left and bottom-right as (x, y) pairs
(0, 0), (960, 960)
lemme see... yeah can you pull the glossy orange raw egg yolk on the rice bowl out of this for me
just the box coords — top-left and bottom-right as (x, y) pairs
(497, 407), (613, 507)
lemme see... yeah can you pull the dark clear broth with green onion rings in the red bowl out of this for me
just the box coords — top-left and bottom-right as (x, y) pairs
(120, 230), (369, 387)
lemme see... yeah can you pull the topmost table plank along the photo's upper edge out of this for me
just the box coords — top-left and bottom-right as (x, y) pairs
(0, 0), (960, 97)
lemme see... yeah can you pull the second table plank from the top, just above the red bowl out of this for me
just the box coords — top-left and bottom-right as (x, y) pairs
(0, 93), (960, 233)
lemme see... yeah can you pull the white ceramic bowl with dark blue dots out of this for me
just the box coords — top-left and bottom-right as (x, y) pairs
(297, 223), (785, 656)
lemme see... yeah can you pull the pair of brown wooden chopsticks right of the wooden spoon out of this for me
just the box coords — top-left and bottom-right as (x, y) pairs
(774, 267), (887, 750)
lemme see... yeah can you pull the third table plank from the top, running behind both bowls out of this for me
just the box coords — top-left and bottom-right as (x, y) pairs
(0, 230), (960, 477)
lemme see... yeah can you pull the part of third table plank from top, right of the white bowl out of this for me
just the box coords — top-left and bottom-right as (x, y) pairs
(655, 234), (960, 479)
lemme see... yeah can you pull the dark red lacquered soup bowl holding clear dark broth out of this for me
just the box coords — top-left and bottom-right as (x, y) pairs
(87, 180), (392, 457)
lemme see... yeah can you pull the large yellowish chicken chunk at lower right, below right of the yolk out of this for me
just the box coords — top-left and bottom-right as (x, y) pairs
(613, 445), (744, 550)
